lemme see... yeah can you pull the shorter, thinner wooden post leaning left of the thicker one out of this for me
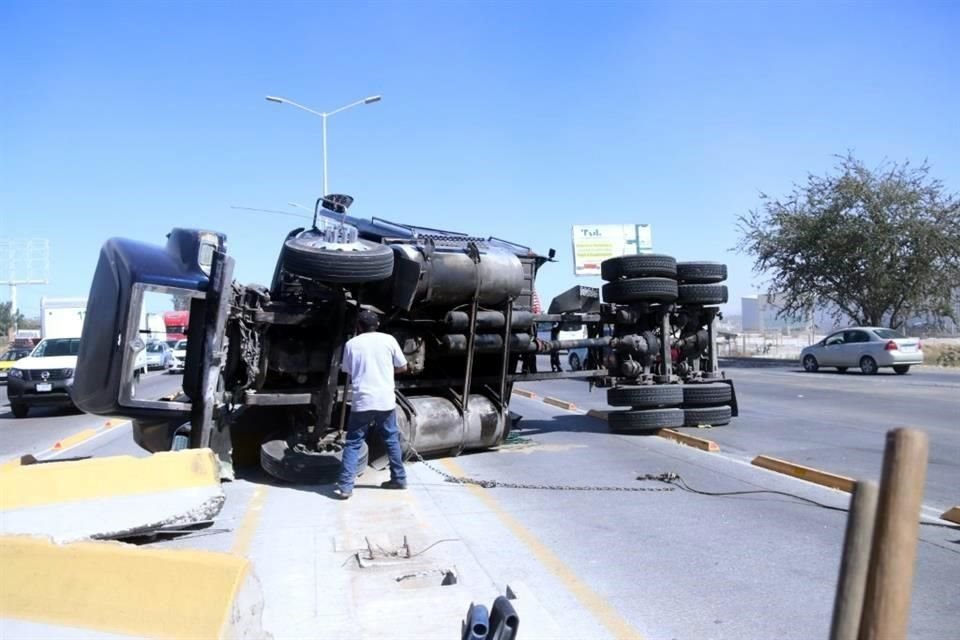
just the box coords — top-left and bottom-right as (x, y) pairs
(830, 481), (877, 640)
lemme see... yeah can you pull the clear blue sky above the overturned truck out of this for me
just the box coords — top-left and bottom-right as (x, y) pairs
(0, 0), (960, 316)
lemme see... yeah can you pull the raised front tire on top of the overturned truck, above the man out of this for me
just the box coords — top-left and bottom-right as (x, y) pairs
(280, 231), (393, 284)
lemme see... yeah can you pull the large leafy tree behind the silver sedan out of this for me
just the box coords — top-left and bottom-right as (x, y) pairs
(738, 153), (960, 328)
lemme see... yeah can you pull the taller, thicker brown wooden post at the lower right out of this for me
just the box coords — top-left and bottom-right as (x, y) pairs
(860, 429), (929, 640)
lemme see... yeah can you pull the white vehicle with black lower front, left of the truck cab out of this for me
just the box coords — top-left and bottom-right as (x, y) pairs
(7, 338), (80, 418)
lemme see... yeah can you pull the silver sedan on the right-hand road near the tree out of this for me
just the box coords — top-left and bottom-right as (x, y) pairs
(800, 327), (923, 375)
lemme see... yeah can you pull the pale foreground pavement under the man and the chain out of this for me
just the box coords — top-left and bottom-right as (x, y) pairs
(16, 394), (960, 640)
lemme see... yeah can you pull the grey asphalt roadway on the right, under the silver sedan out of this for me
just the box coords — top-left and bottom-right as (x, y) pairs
(518, 363), (960, 513)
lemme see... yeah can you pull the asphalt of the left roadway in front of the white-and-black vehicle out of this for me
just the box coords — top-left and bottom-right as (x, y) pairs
(0, 371), (181, 461)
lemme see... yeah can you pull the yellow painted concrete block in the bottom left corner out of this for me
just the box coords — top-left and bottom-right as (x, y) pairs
(0, 536), (262, 638)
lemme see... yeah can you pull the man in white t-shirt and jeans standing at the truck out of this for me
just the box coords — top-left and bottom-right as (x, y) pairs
(334, 311), (407, 500)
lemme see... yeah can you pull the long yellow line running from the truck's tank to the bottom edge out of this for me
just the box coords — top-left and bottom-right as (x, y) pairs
(440, 459), (643, 640)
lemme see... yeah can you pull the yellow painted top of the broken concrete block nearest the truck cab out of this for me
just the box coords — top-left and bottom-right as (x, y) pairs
(0, 450), (220, 515)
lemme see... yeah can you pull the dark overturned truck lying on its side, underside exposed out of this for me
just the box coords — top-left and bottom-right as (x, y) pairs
(73, 195), (737, 482)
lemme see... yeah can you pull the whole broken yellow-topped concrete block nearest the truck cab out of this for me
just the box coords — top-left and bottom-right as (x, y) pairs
(0, 449), (224, 542)
